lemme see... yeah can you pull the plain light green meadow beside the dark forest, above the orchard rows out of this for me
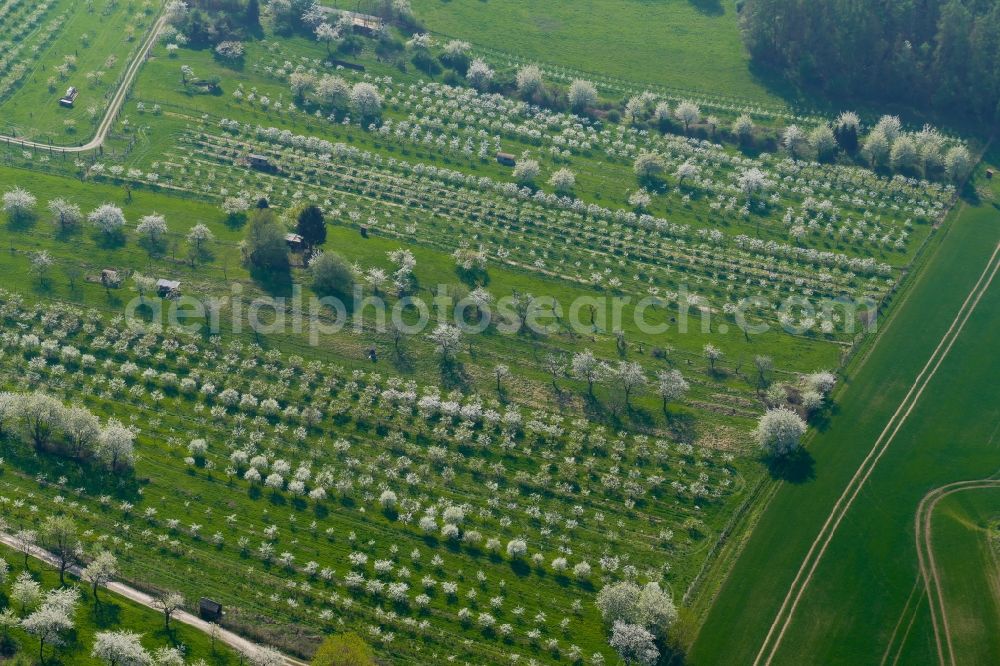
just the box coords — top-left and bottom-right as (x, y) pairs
(413, 0), (780, 103)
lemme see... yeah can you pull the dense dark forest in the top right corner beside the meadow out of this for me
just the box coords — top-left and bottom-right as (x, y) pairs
(742, 0), (1000, 122)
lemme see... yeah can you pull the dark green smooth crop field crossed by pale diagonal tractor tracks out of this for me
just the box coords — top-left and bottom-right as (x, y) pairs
(689, 152), (1000, 664)
